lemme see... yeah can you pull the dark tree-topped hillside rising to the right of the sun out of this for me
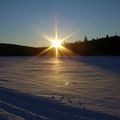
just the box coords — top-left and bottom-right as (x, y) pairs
(63, 35), (120, 55)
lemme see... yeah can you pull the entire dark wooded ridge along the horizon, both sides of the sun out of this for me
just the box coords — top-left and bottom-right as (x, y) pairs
(0, 35), (120, 56)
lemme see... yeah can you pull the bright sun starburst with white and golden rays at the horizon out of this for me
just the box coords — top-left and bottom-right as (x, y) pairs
(38, 18), (78, 58)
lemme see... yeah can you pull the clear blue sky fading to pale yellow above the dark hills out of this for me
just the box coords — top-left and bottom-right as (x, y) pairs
(0, 0), (120, 47)
